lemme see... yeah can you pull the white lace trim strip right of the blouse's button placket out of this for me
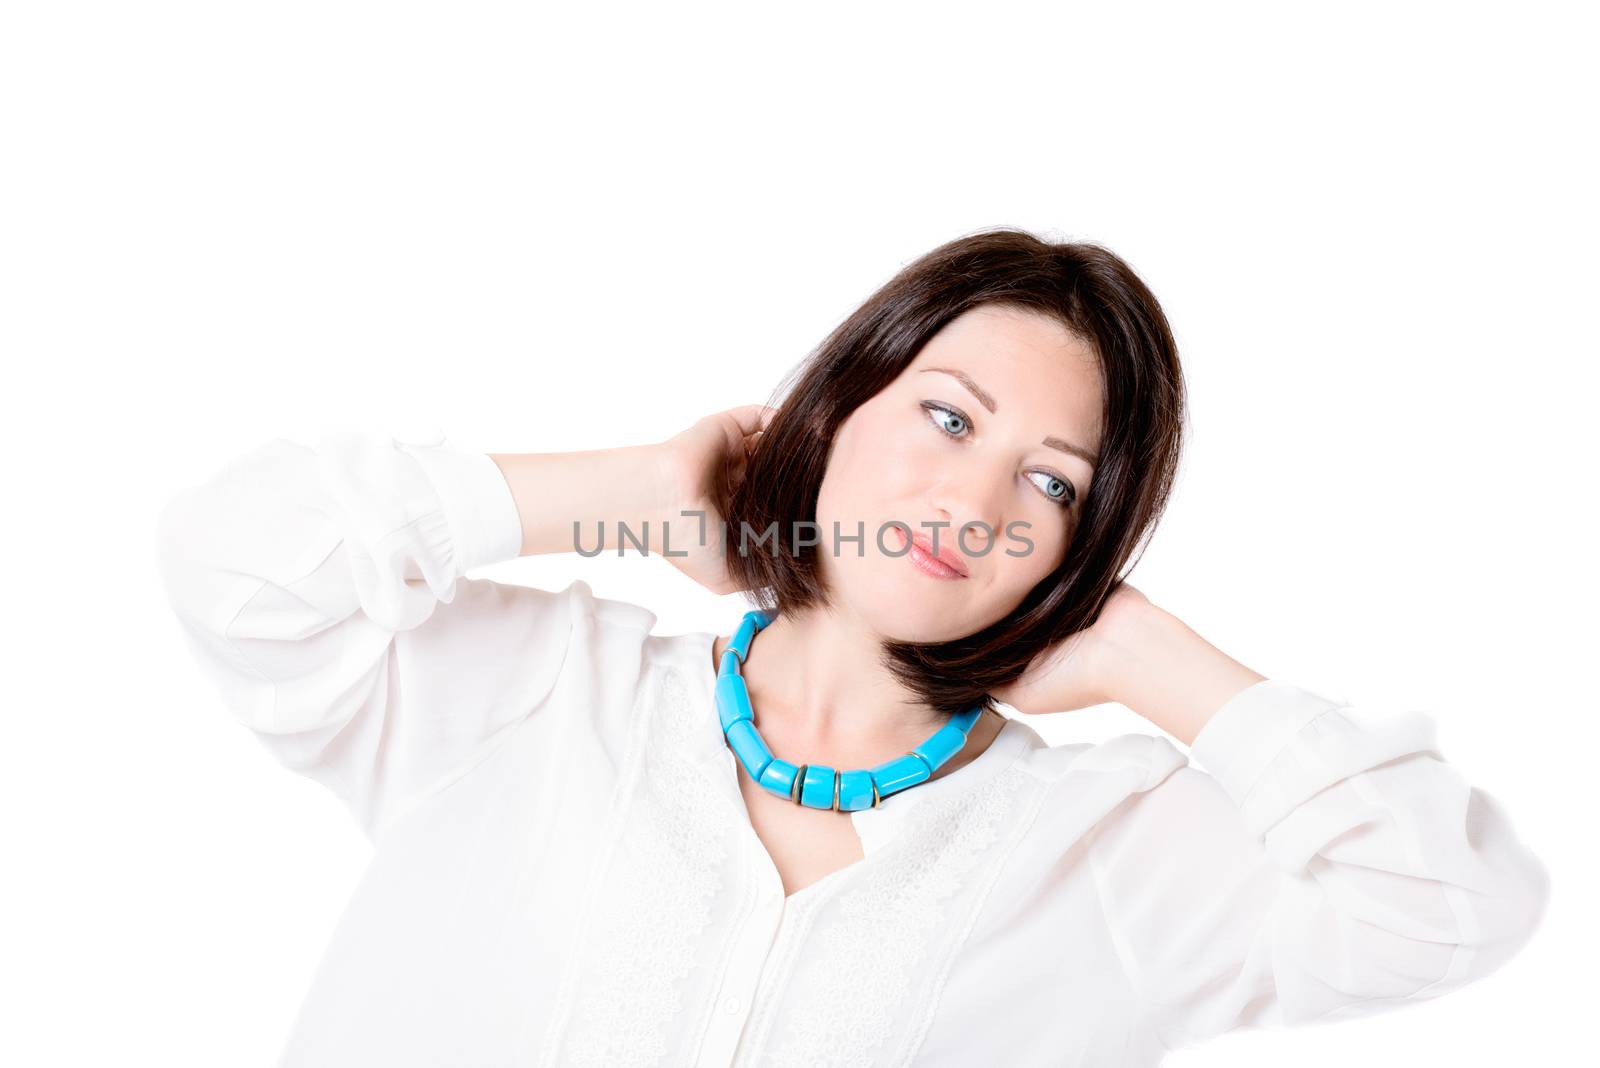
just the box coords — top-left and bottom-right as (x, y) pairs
(741, 766), (1037, 1068)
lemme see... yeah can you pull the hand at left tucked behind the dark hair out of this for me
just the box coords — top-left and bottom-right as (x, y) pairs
(661, 404), (778, 596)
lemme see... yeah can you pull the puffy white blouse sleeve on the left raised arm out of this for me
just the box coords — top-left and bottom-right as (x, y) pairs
(158, 433), (594, 839)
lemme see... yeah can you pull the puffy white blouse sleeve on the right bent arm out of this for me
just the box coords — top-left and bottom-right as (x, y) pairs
(1088, 679), (1549, 1049)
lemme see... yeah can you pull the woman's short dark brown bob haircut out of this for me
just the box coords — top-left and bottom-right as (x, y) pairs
(722, 227), (1186, 715)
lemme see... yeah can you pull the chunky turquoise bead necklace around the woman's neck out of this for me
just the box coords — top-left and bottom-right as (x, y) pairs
(715, 611), (984, 812)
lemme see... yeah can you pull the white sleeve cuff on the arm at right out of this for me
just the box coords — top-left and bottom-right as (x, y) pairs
(1189, 678), (1342, 807)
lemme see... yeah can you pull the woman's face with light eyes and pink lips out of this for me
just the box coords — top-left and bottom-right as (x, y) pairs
(816, 305), (1102, 641)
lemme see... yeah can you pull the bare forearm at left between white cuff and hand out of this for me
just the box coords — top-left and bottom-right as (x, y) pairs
(490, 444), (693, 556)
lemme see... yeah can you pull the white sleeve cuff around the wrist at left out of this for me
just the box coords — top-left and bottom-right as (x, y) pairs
(395, 435), (522, 574)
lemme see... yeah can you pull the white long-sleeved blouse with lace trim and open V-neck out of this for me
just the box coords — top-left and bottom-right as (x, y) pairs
(152, 433), (1549, 1068)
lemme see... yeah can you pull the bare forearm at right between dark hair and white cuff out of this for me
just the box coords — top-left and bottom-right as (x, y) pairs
(1102, 604), (1266, 745)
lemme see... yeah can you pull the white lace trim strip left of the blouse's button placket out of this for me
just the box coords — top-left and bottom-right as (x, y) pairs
(558, 665), (728, 1068)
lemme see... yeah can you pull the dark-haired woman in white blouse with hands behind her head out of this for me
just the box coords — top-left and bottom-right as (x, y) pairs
(162, 230), (1549, 1066)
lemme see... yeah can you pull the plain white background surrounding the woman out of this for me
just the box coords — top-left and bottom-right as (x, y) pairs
(0, 0), (1600, 1066)
